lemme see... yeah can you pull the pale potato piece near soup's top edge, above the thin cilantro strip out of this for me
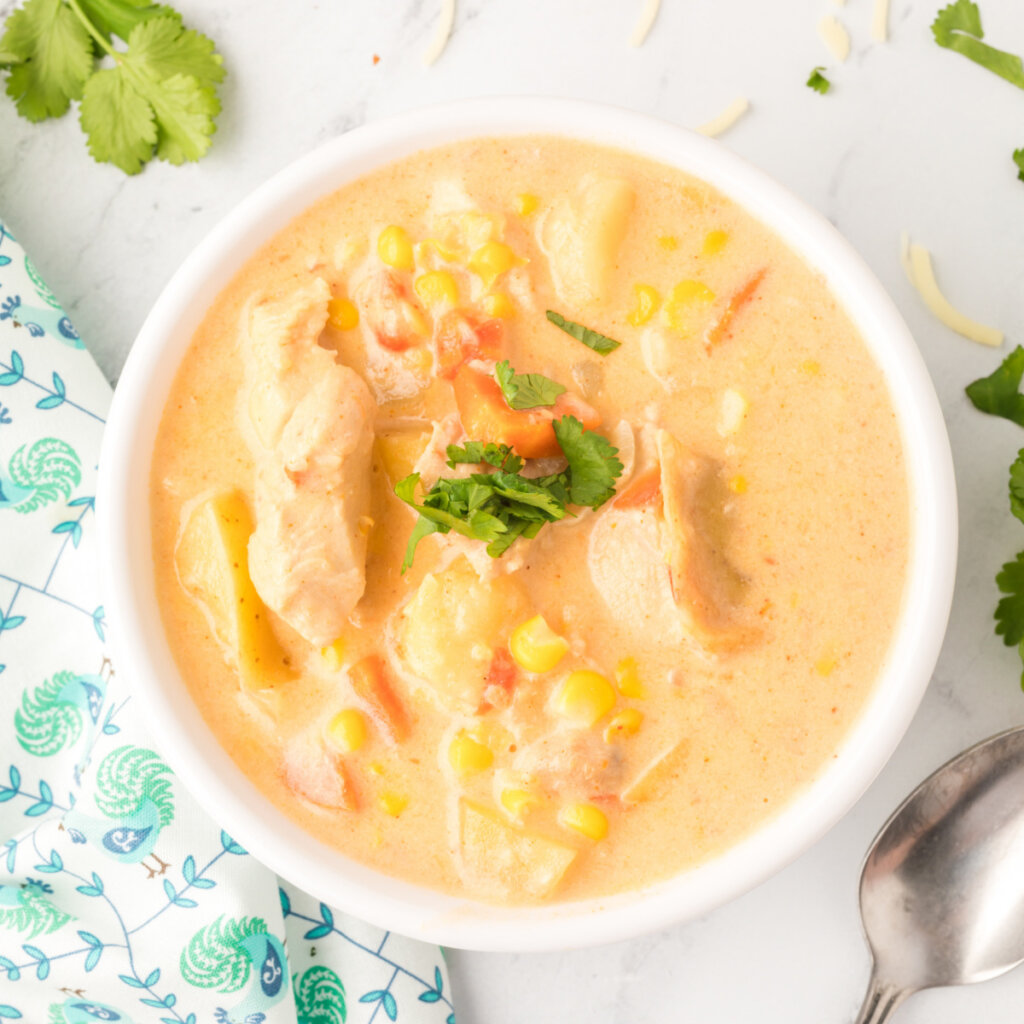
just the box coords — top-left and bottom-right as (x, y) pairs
(541, 175), (636, 306)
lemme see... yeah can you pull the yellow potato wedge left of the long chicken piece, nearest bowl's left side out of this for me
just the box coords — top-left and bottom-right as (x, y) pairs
(174, 490), (294, 690)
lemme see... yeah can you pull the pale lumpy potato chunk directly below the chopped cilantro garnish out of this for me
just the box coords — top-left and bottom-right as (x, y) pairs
(395, 558), (528, 714)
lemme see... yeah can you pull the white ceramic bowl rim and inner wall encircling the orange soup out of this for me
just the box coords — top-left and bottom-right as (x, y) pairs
(96, 98), (956, 950)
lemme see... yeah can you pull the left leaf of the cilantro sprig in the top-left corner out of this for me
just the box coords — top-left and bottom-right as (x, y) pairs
(0, 0), (95, 121)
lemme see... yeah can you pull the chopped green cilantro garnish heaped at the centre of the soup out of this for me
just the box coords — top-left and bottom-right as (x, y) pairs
(394, 416), (623, 572)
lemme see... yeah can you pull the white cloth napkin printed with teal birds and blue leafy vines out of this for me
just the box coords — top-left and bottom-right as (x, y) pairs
(0, 221), (455, 1024)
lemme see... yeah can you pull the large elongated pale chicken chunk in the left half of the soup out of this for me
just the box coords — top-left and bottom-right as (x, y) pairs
(243, 281), (376, 646)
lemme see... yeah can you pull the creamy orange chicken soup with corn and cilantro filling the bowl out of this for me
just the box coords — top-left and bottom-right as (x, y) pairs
(152, 137), (908, 903)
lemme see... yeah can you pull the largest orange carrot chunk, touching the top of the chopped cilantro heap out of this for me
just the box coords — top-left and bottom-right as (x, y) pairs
(452, 367), (601, 459)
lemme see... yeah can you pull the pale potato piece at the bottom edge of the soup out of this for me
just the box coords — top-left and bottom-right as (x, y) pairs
(459, 800), (577, 899)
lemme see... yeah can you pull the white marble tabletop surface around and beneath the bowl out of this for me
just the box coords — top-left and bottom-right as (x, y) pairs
(0, 0), (1024, 1024)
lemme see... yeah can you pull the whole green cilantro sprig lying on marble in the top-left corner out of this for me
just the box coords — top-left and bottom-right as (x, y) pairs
(0, 0), (224, 174)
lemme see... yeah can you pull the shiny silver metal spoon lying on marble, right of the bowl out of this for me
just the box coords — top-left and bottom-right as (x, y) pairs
(857, 727), (1024, 1024)
